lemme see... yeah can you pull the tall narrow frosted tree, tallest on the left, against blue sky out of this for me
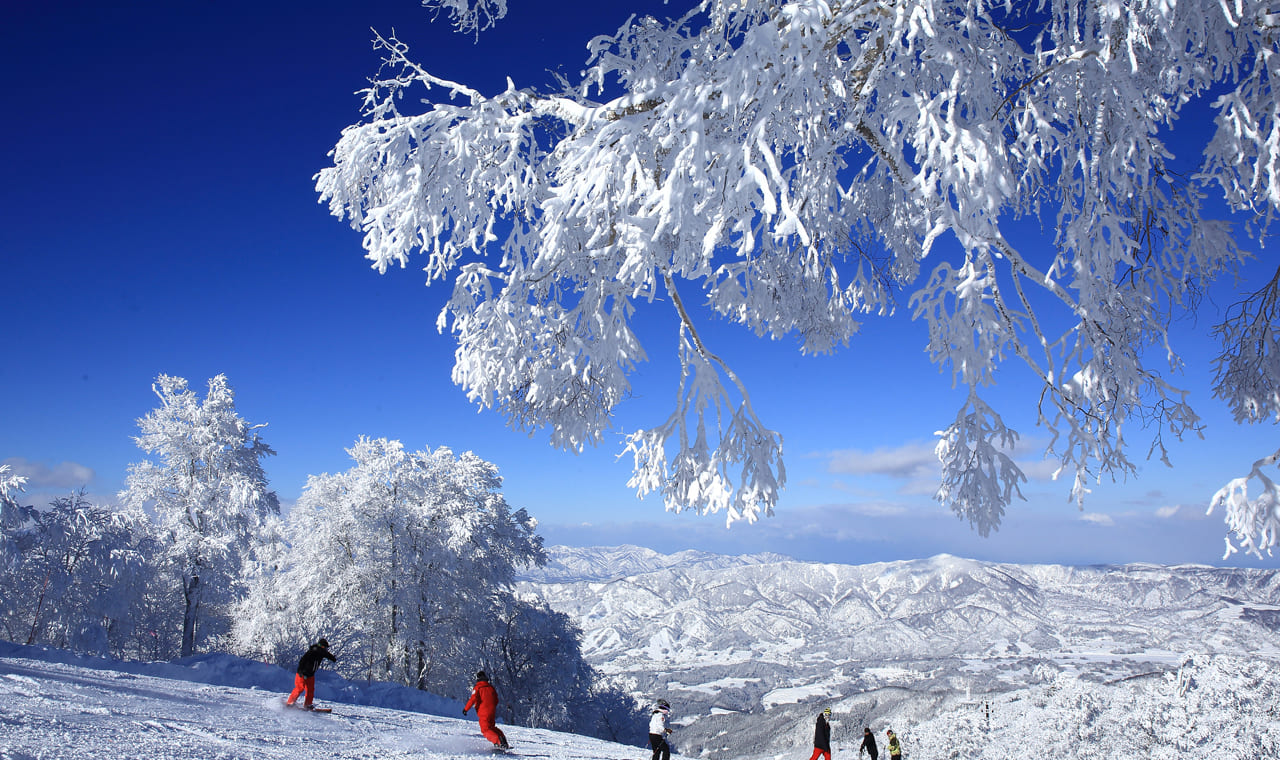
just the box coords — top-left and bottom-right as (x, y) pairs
(120, 375), (280, 656)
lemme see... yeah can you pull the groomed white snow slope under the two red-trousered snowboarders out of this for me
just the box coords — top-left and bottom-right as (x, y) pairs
(0, 644), (648, 760)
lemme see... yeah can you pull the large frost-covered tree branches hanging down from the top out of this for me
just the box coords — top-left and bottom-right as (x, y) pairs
(316, 0), (1280, 550)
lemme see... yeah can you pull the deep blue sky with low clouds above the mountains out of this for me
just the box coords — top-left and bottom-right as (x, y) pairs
(0, 0), (1276, 567)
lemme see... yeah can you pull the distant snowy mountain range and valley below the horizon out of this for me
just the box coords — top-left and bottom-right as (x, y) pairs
(521, 546), (1280, 757)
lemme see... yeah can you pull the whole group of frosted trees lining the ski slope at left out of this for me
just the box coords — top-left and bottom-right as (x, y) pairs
(0, 375), (639, 738)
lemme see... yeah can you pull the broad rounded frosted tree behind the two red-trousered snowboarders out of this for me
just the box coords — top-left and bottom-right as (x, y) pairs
(234, 439), (545, 696)
